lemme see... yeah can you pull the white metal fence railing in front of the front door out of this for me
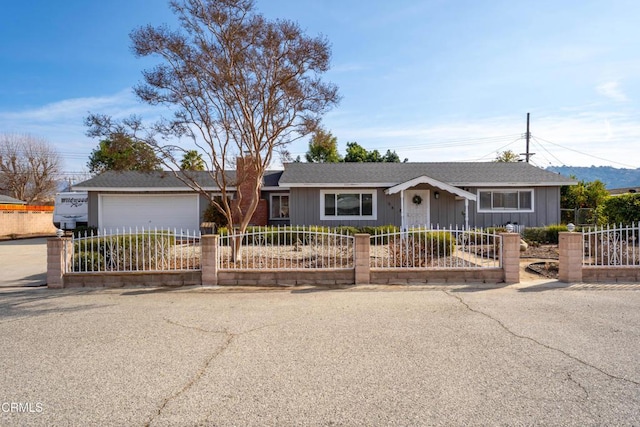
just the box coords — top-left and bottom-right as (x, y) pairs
(370, 227), (502, 269)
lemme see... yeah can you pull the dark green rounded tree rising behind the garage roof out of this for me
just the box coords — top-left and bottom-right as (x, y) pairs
(87, 133), (161, 173)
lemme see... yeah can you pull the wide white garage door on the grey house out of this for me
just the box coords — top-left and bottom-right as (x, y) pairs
(98, 194), (200, 232)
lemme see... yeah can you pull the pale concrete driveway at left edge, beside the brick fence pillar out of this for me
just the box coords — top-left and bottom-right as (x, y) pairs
(0, 237), (47, 287)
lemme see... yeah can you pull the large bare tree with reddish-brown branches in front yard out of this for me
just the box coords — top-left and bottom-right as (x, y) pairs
(87, 0), (339, 241)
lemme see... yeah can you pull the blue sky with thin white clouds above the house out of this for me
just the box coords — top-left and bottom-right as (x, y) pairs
(0, 0), (640, 176)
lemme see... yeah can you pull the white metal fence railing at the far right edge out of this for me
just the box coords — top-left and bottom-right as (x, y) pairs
(582, 223), (640, 267)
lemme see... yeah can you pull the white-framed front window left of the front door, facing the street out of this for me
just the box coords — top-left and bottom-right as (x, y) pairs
(320, 190), (376, 220)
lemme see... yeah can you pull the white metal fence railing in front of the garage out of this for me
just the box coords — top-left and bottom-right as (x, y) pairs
(65, 228), (201, 273)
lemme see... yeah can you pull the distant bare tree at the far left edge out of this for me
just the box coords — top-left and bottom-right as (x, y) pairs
(0, 134), (61, 204)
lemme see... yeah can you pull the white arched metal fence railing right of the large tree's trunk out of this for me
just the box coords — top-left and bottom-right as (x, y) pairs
(218, 227), (354, 270)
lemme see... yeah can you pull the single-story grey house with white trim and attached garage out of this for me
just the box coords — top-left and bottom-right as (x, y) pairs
(73, 162), (576, 229)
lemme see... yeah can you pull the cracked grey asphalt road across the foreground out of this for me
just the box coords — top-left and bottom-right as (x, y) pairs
(0, 284), (640, 426)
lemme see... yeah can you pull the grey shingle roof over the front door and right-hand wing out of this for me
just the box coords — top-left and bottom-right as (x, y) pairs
(280, 162), (575, 187)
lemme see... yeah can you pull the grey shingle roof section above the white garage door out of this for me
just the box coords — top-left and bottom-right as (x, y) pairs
(73, 171), (282, 192)
